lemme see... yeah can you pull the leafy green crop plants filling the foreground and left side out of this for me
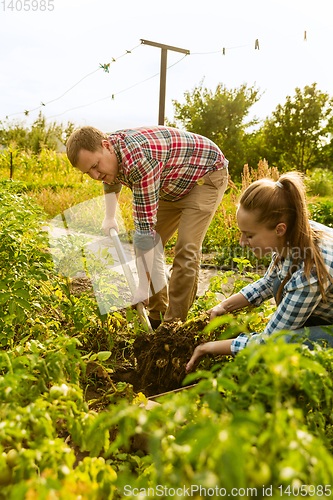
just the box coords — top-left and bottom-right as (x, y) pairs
(0, 181), (333, 500)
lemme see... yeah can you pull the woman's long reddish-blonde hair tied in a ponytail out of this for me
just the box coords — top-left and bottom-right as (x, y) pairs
(239, 172), (333, 304)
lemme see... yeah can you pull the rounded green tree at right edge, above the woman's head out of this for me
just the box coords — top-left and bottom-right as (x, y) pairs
(262, 83), (333, 172)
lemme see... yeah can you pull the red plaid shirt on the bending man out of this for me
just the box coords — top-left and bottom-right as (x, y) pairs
(104, 127), (228, 234)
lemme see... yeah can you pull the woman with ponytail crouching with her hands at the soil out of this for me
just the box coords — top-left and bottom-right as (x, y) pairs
(186, 172), (333, 371)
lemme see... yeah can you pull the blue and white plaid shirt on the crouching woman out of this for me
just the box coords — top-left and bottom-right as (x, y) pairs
(231, 221), (333, 355)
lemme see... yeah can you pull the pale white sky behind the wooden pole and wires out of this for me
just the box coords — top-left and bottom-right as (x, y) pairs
(0, 0), (333, 132)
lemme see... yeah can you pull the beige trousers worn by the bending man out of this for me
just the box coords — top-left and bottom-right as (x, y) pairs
(148, 168), (228, 321)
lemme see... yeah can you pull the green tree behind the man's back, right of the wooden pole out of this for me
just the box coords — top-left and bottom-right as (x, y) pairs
(168, 81), (260, 176)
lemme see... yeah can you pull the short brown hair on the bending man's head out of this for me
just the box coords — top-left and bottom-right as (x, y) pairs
(66, 127), (108, 167)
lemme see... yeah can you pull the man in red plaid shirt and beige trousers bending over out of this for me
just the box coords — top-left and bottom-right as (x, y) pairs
(67, 126), (228, 328)
